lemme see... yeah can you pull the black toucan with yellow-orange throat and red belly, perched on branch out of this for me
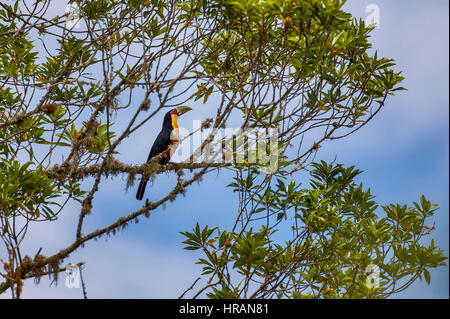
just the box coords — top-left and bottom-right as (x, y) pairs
(136, 105), (192, 200)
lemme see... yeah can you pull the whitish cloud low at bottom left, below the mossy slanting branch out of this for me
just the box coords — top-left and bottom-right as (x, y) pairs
(2, 235), (199, 298)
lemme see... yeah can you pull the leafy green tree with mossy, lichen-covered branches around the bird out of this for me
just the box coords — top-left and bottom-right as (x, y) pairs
(0, 0), (445, 298)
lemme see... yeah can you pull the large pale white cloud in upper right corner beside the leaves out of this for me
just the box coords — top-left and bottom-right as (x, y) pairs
(327, 0), (449, 157)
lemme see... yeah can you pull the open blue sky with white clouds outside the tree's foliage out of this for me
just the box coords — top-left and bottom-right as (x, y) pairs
(2, 0), (449, 298)
